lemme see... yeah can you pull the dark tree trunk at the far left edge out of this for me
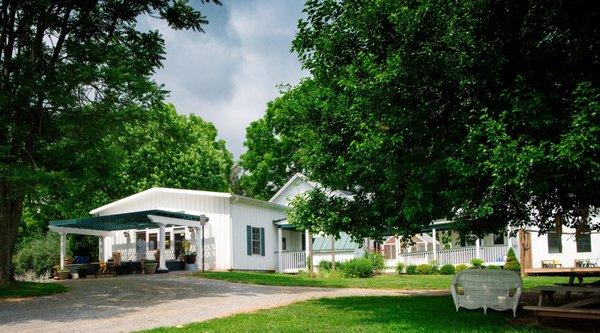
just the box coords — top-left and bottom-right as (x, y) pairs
(0, 180), (23, 285)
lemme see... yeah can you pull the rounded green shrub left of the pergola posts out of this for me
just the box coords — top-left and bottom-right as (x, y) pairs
(13, 232), (60, 276)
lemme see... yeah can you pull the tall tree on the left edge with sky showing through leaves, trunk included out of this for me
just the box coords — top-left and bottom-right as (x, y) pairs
(0, 0), (218, 283)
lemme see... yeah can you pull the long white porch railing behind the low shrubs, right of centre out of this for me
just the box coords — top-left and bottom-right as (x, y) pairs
(390, 245), (508, 265)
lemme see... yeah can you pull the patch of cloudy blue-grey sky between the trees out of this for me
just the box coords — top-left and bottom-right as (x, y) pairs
(138, 0), (308, 160)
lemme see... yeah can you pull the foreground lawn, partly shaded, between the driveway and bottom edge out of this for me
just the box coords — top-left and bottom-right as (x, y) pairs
(148, 296), (542, 333)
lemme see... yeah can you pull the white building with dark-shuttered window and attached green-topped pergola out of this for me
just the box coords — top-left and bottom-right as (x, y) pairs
(50, 188), (306, 271)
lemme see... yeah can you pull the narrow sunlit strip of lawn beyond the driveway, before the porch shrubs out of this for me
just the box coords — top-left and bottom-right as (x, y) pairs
(196, 272), (568, 289)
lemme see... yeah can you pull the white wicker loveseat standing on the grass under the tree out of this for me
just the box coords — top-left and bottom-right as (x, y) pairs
(450, 269), (523, 317)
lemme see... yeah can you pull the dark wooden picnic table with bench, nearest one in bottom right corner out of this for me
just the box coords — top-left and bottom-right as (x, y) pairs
(523, 286), (600, 320)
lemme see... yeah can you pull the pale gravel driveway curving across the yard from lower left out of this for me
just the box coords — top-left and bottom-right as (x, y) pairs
(0, 273), (448, 333)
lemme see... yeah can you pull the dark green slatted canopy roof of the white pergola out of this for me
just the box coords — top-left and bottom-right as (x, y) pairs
(50, 209), (202, 231)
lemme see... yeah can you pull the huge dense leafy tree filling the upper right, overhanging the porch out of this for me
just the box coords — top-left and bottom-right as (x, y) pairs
(251, 0), (600, 237)
